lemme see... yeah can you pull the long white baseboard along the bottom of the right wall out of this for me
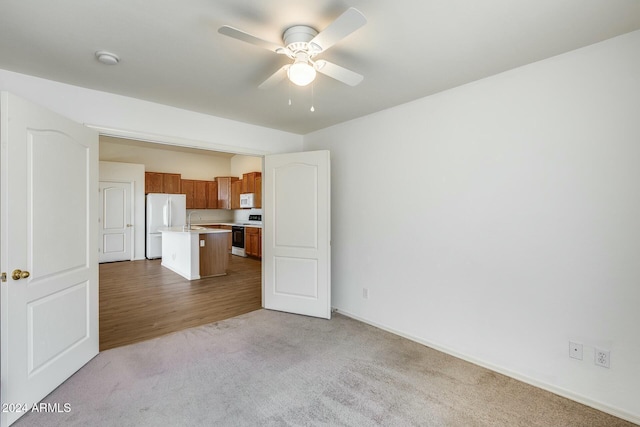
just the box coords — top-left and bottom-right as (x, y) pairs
(332, 307), (640, 425)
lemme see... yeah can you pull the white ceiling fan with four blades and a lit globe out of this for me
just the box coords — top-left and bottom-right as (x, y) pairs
(218, 7), (367, 89)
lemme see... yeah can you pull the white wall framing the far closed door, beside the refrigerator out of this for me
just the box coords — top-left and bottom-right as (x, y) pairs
(99, 162), (145, 259)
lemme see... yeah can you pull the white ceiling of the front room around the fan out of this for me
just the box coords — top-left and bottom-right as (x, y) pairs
(0, 0), (640, 134)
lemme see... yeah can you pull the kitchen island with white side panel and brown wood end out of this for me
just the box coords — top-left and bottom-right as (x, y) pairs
(159, 227), (231, 280)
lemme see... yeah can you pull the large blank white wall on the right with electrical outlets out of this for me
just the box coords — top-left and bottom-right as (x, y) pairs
(304, 32), (640, 423)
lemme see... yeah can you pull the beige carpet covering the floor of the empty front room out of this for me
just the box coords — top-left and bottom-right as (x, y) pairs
(15, 310), (632, 427)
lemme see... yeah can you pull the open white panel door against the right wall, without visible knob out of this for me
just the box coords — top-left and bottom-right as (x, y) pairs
(262, 151), (331, 319)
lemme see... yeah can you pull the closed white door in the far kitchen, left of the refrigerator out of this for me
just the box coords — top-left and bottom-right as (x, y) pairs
(98, 181), (133, 262)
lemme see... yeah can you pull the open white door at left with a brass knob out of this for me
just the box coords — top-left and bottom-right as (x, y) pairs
(0, 92), (98, 427)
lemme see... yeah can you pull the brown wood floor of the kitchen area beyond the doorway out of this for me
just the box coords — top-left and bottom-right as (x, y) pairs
(100, 255), (262, 351)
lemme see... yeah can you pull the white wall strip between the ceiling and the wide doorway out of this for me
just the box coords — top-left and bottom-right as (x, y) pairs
(0, 70), (302, 155)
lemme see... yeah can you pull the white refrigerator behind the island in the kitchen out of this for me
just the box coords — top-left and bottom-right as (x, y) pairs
(146, 193), (187, 259)
